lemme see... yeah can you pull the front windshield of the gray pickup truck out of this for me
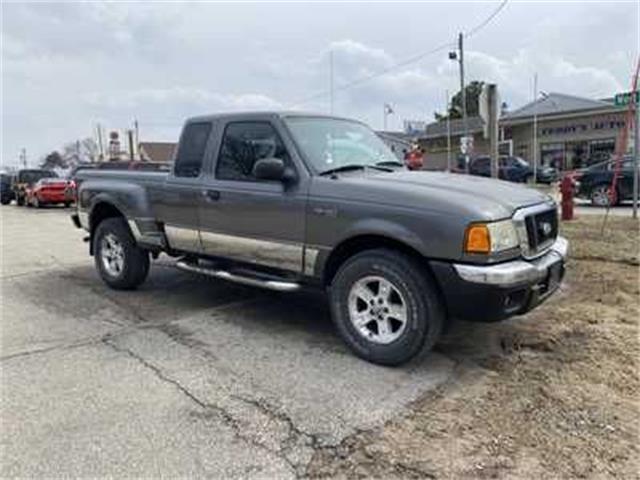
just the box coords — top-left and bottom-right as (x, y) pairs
(285, 117), (403, 174)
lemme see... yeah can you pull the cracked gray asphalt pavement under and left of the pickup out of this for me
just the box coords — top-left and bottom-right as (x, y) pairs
(0, 206), (453, 478)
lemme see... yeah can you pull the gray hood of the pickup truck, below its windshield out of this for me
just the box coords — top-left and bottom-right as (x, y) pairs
(322, 170), (550, 220)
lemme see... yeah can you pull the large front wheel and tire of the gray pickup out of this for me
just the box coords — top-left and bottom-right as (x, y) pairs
(329, 249), (445, 366)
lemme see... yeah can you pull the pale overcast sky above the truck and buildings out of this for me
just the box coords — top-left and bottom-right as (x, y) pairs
(0, 0), (640, 165)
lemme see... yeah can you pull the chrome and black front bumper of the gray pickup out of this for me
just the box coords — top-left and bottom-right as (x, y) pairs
(431, 237), (569, 322)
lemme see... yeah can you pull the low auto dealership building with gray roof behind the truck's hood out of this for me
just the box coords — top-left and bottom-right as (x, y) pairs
(418, 93), (626, 170)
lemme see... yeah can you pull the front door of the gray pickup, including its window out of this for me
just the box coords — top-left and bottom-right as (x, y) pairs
(200, 117), (308, 273)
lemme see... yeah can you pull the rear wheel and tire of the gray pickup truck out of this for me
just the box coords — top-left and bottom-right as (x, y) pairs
(93, 217), (149, 290)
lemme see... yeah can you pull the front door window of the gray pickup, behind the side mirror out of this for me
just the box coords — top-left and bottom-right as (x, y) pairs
(216, 122), (291, 182)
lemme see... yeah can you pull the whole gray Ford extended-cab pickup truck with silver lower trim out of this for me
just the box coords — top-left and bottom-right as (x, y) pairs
(73, 113), (567, 365)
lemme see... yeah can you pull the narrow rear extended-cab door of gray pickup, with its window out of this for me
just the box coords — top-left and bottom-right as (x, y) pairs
(151, 122), (212, 253)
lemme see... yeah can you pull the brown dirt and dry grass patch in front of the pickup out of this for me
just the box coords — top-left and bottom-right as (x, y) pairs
(307, 217), (640, 478)
